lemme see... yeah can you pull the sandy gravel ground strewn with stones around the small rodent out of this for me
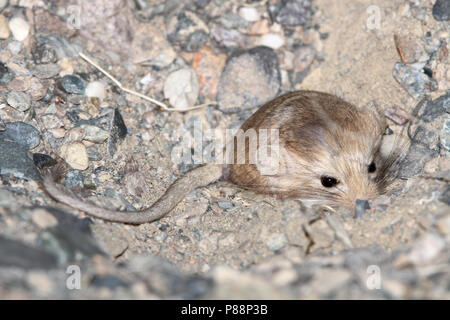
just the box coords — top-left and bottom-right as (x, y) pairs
(0, 0), (450, 299)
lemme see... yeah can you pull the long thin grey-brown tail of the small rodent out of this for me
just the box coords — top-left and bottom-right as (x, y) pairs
(43, 164), (222, 224)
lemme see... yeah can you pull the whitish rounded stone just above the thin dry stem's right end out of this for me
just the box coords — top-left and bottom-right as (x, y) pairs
(164, 69), (199, 109)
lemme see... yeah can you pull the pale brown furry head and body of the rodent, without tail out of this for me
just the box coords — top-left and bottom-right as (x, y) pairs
(230, 91), (392, 205)
